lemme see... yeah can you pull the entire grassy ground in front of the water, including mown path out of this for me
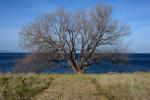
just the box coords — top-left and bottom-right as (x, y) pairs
(0, 73), (150, 100)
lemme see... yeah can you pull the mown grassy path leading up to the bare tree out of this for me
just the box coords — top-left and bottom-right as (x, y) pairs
(36, 76), (100, 100)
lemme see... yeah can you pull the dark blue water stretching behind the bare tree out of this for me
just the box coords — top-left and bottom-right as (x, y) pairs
(0, 53), (150, 73)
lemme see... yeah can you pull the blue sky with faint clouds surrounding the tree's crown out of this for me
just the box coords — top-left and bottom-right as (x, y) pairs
(0, 0), (150, 53)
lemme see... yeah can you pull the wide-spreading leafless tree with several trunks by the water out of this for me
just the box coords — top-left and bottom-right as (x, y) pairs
(20, 6), (129, 73)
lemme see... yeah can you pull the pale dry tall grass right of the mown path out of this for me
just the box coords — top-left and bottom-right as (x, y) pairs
(93, 73), (150, 100)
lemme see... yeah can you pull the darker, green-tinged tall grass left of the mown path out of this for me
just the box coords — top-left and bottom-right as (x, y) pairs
(0, 74), (53, 100)
